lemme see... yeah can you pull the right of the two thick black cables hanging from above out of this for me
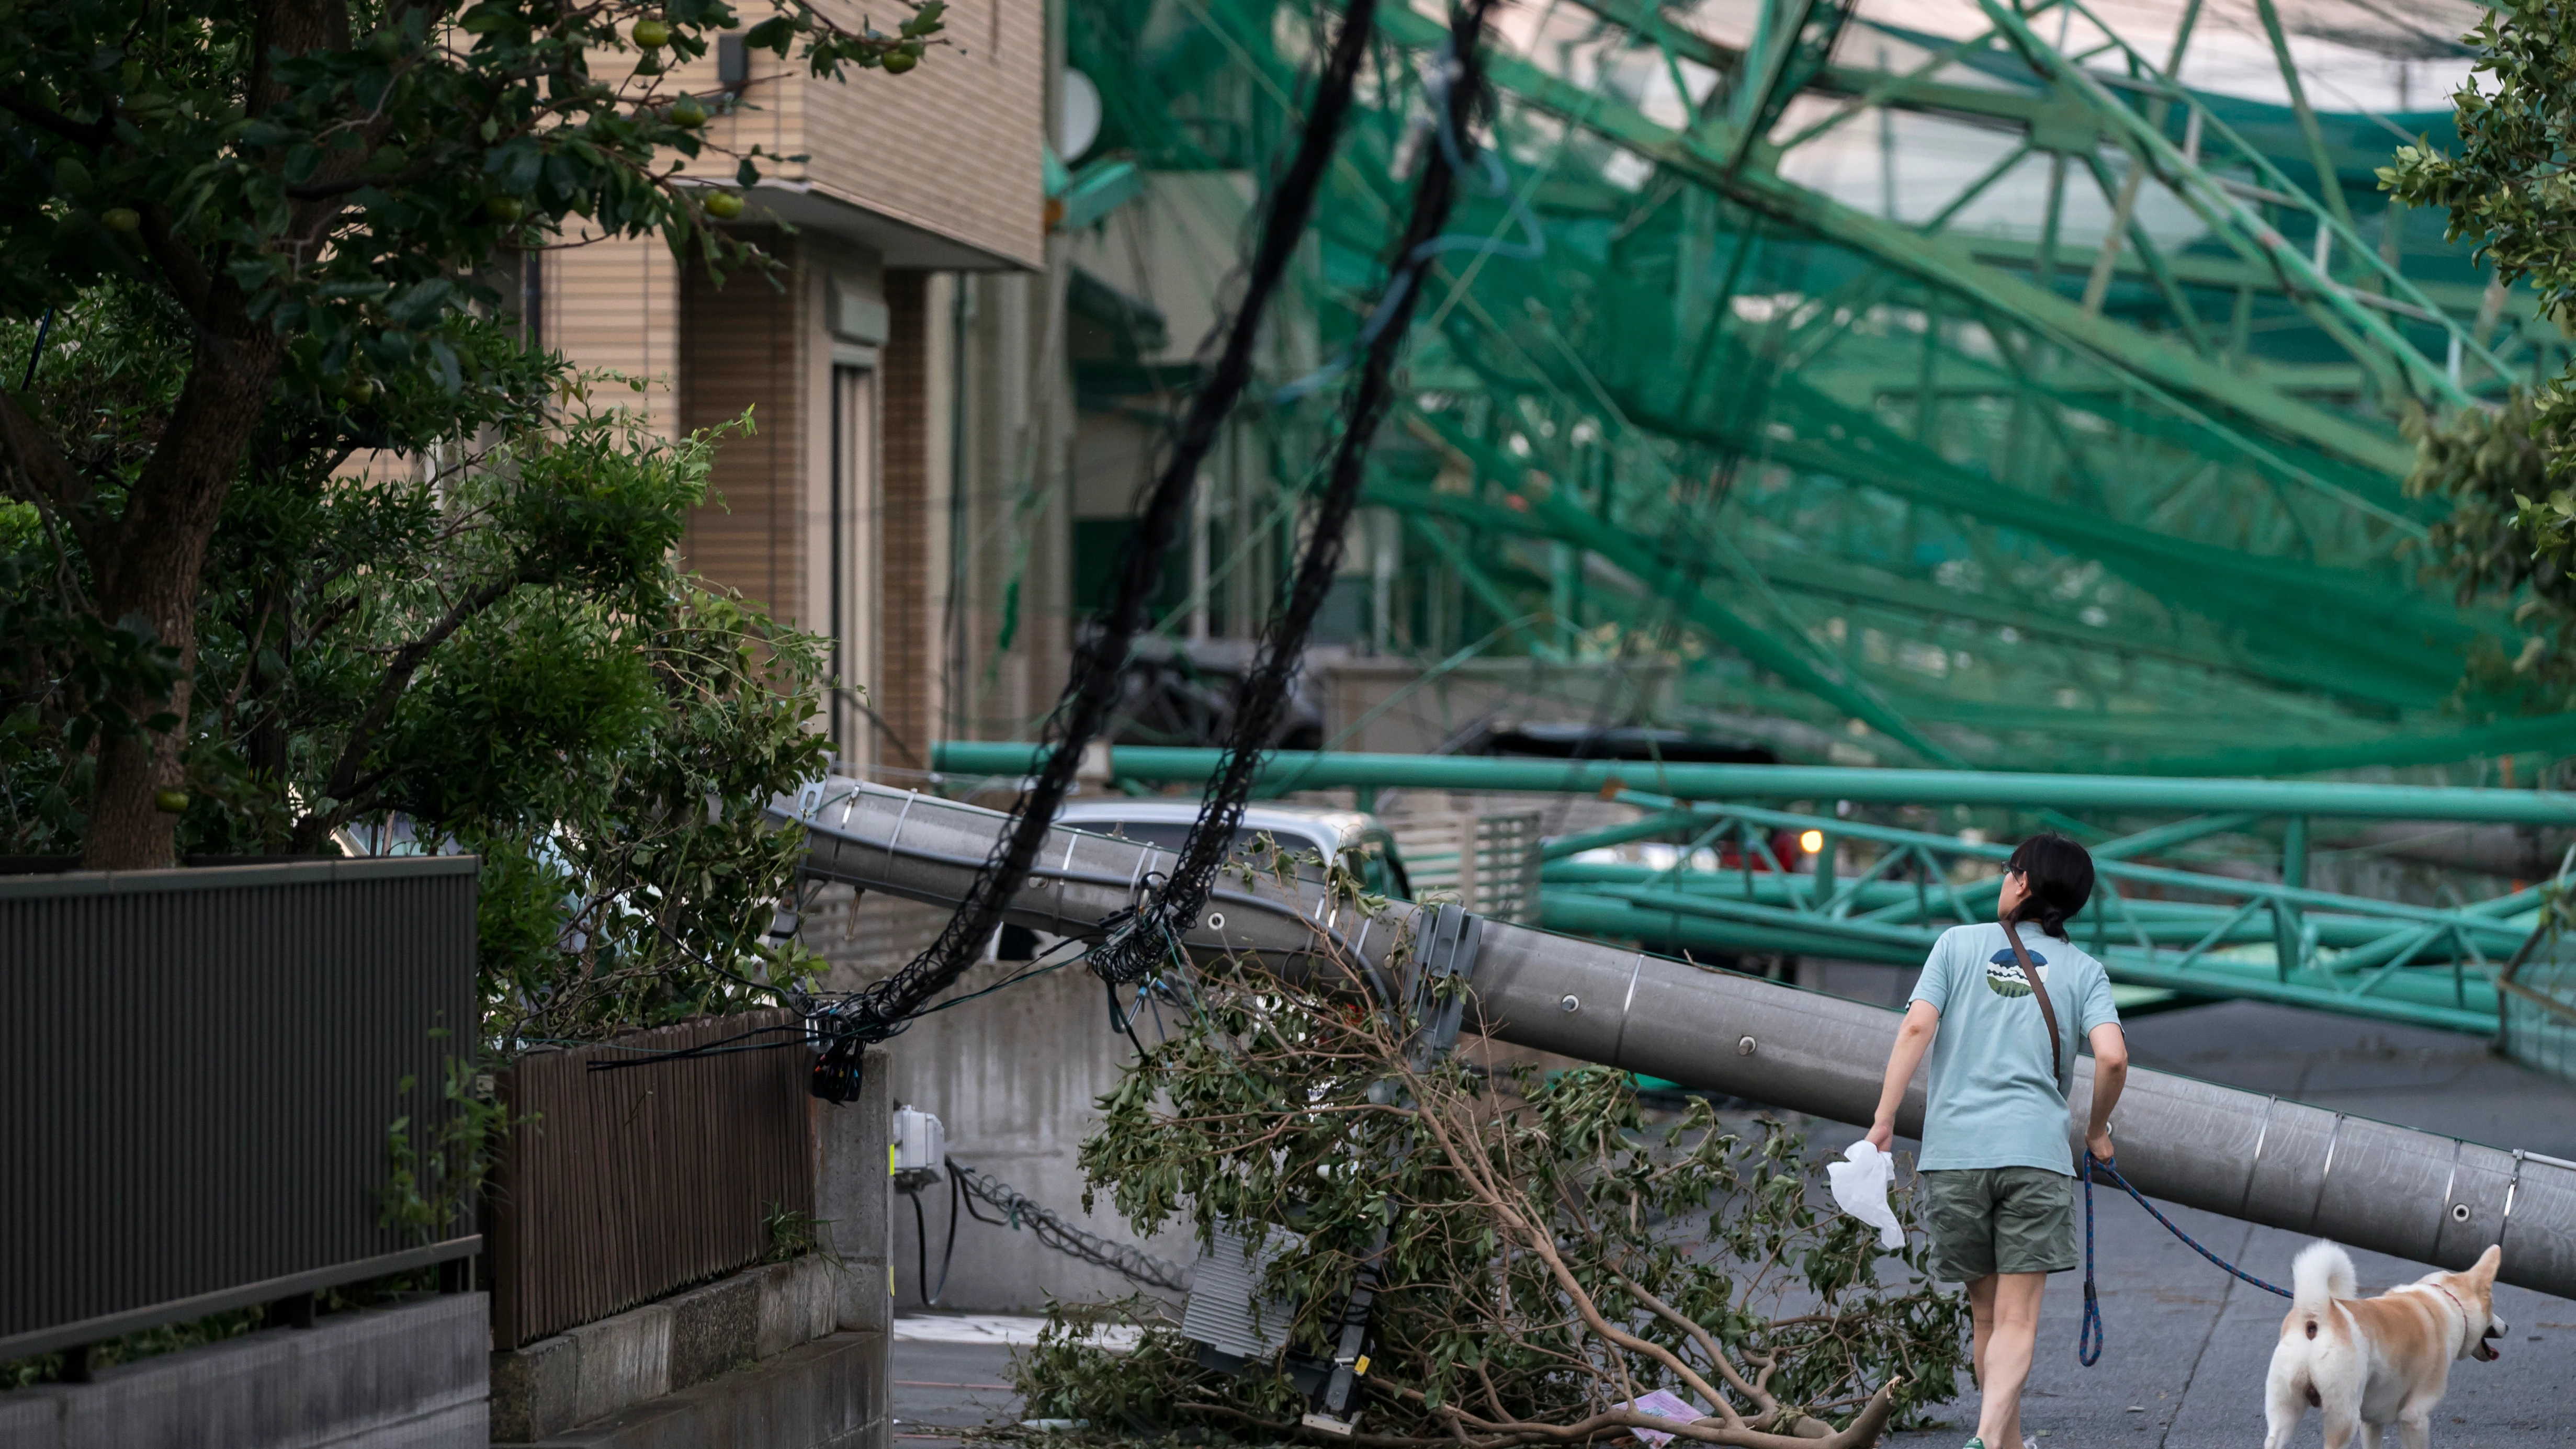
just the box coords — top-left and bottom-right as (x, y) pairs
(1092, 0), (1494, 983)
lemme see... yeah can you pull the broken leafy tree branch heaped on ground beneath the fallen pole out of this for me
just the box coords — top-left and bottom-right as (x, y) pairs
(1015, 947), (1965, 1449)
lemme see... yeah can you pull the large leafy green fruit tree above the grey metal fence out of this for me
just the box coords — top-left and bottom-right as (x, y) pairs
(0, 0), (940, 870)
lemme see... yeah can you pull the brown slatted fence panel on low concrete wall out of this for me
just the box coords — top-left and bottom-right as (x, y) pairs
(484, 1012), (814, 1349)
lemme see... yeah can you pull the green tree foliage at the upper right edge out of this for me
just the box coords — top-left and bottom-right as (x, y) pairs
(2380, 5), (2576, 713)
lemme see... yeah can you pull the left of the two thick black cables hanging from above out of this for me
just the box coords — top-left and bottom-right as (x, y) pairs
(814, 0), (1378, 1102)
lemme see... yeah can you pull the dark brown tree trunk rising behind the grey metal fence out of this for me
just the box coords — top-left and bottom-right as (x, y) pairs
(80, 323), (281, 870)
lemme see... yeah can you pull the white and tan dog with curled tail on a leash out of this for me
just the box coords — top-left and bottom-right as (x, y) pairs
(2264, 1243), (2506, 1449)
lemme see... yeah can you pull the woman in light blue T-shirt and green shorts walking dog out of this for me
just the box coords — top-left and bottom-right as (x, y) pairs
(1870, 834), (2128, 1449)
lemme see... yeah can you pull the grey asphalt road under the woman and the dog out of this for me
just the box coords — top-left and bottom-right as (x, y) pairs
(894, 1003), (2576, 1449)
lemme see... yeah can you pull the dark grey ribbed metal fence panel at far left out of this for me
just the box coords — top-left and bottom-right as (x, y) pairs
(0, 857), (477, 1359)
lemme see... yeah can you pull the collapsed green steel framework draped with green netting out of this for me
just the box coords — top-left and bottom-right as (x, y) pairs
(1067, 0), (2566, 775)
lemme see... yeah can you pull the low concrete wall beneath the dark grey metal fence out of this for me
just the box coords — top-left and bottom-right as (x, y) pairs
(0, 1292), (492, 1449)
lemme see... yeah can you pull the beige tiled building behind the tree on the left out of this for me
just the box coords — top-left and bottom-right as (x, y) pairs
(530, 0), (1071, 772)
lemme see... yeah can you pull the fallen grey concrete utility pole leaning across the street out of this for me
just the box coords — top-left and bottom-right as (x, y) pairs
(770, 780), (2576, 1297)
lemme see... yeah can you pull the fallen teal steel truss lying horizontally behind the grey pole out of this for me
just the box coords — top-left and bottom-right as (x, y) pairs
(937, 744), (2545, 1035)
